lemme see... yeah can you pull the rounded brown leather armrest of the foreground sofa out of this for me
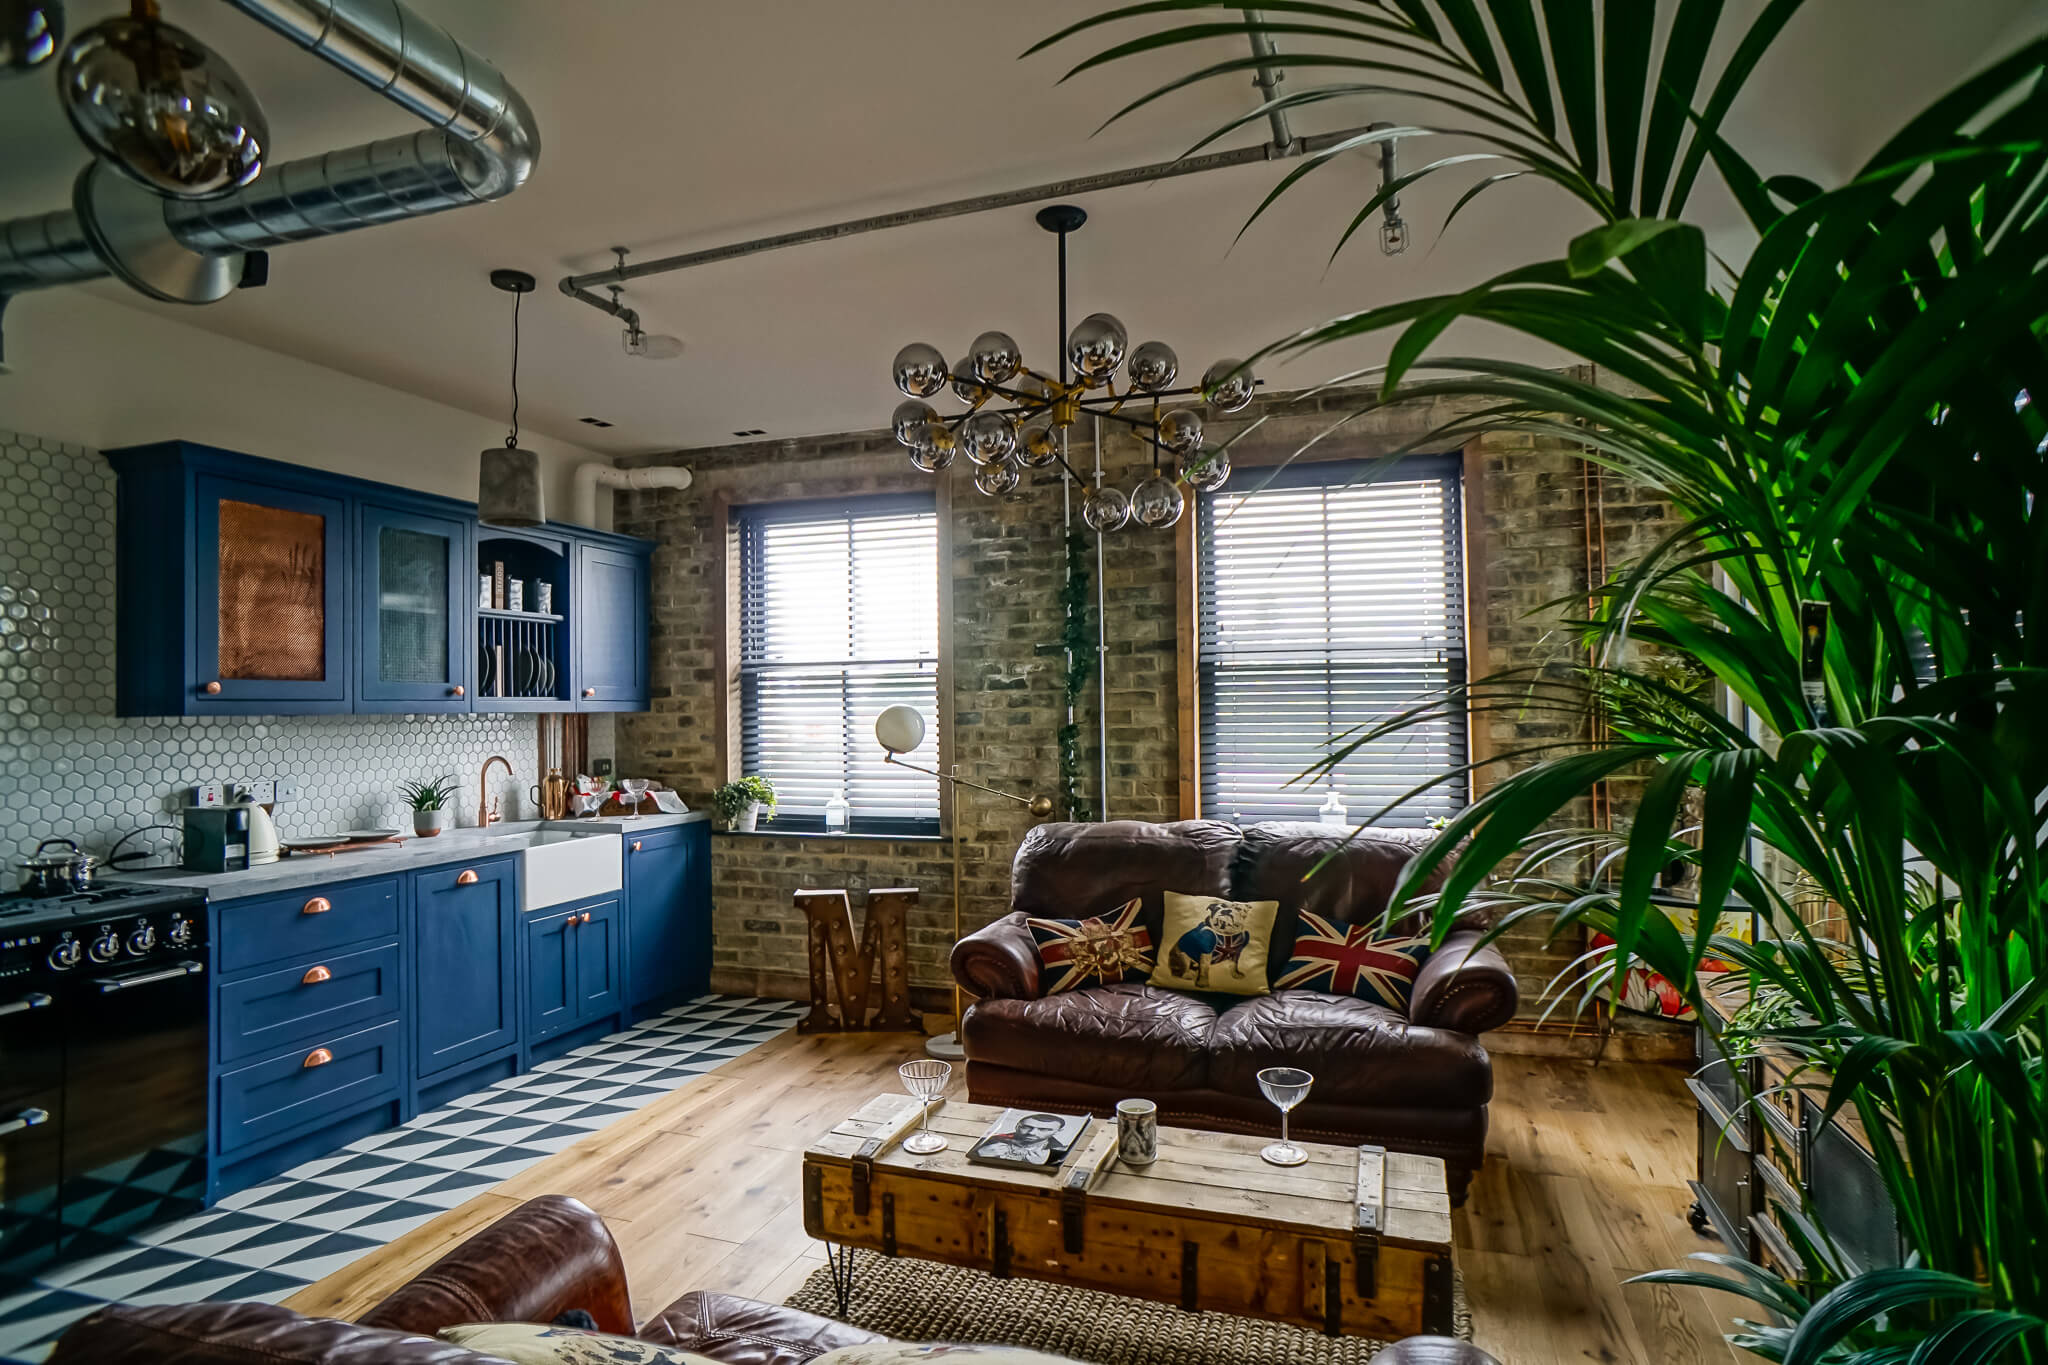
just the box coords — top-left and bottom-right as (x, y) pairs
(360, 1195), (633, 1336)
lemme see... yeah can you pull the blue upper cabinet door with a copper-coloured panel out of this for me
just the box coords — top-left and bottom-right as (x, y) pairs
(188, 477), (348, 714)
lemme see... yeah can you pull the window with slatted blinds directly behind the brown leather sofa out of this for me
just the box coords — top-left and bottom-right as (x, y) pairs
(1196, 456), (1466, 825)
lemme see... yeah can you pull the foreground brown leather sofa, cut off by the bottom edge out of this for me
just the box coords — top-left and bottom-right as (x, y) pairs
(49, 1195), (1499, 1365)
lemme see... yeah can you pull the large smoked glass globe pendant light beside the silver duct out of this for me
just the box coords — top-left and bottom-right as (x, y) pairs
(57, 0), (270, 199)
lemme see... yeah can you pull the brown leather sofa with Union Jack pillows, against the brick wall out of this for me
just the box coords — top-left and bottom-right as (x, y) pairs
(952, 821), (1518, 1203)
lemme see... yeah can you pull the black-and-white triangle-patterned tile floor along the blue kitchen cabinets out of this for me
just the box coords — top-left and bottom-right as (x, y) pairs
(0, 995), (803, 1365)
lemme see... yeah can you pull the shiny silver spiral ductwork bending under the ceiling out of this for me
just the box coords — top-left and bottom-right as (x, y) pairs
(0, 0), (541, 303)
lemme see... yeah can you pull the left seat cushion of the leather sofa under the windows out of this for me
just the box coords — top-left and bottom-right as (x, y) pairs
(961, 984), (1217, 1095)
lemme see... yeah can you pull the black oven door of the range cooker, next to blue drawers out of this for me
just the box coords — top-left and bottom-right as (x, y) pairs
(63, 960), (207, 1257)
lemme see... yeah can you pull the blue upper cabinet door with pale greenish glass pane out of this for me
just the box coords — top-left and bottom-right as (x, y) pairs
(356, 503), (477, 712)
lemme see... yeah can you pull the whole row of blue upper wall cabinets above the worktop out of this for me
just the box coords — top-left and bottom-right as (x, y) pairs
(106, 440), (651, 716)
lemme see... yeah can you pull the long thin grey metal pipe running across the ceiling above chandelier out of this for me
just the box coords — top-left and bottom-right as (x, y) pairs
(559, 10), (1359, 327)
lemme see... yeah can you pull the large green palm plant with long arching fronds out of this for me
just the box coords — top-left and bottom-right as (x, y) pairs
(1040, 0), (2048, 1365)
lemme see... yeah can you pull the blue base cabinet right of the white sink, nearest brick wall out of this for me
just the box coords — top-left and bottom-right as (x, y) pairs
(625, 821), (711, 1019)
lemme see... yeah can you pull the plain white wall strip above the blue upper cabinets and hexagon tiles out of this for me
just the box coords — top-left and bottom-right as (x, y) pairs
(0, 284), (608, 507)
